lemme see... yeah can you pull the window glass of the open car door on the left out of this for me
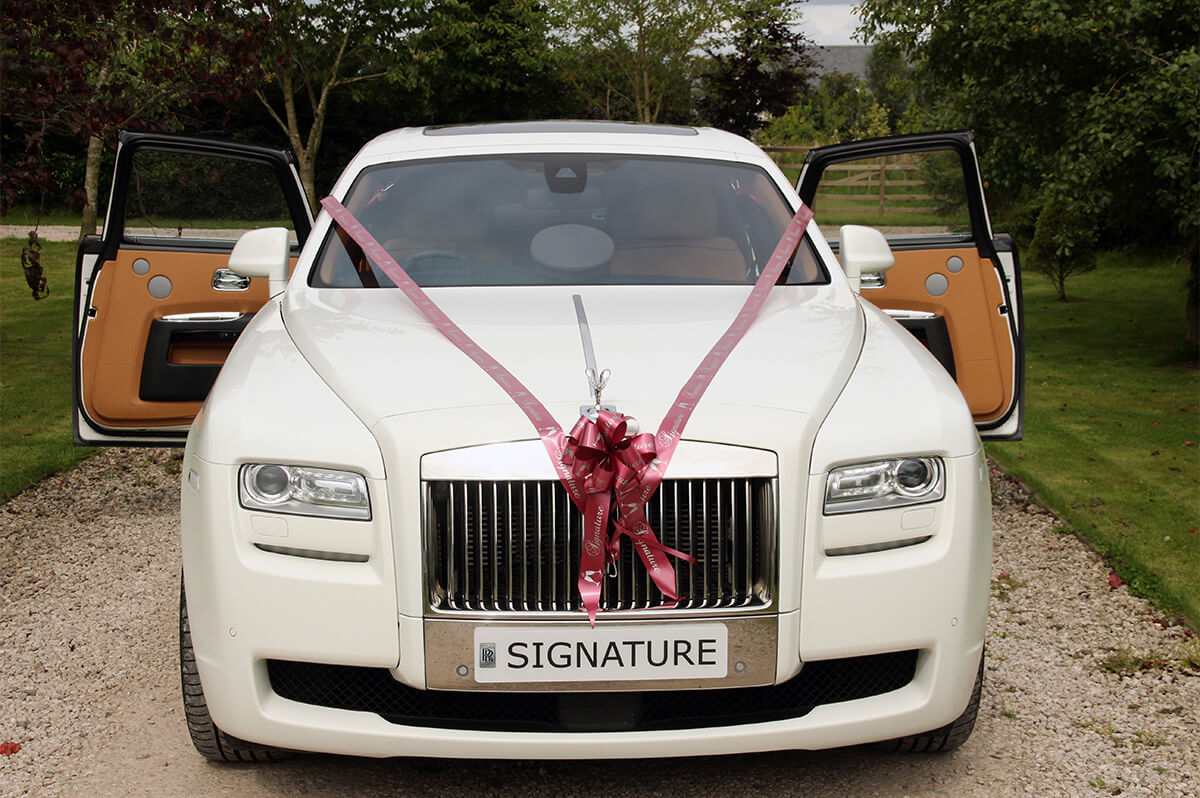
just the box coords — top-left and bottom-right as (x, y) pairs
(124, 149), (295, 242)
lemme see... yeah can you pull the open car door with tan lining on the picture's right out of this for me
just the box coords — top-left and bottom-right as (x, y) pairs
(796, 131), (1025, 440)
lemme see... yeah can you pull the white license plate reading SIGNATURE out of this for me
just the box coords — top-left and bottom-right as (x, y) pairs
(475, 624), (728, 684)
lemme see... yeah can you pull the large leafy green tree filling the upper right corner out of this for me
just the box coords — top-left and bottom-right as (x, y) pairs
(860, 0), (1200, 304)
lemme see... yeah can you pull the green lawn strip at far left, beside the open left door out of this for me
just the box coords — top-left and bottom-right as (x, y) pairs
(0, 239), (92, 498)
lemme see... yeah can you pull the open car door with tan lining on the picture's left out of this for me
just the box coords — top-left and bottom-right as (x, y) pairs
(73, 132), (312, 445)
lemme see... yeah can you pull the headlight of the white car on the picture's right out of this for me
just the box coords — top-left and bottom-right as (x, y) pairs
(824, 457), (946, 515)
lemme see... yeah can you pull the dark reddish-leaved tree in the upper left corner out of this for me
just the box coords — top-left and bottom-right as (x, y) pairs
(0, 0), (270, 235)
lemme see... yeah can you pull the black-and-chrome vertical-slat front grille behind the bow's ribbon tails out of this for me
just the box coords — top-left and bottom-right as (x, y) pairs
(424, 478), (776, 612)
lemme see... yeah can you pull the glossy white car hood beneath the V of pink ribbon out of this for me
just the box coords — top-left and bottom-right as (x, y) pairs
(283, 286), (864, 433)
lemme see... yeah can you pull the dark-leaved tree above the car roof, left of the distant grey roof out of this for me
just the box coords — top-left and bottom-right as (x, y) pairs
(697, 0), (816, 136)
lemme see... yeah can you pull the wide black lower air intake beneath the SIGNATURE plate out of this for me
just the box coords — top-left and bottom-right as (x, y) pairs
(268, 650), (917, 732)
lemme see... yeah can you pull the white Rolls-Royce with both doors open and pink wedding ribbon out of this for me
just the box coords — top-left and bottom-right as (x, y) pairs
(76, 121), (1022, 760)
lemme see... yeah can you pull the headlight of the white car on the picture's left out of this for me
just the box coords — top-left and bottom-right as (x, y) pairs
(238, 463), (371, 521)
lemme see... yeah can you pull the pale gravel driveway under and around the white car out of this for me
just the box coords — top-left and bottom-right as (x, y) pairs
(0, 449), (1200, 798)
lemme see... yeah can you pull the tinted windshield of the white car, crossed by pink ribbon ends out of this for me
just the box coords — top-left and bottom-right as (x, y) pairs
(308, 154), (828, 288)
